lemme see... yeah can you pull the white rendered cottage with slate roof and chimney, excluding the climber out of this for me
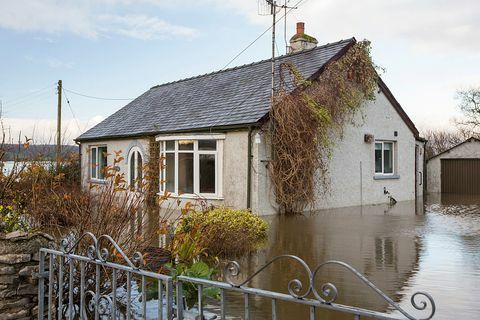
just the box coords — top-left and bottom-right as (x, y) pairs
(77, 26), (424, 215)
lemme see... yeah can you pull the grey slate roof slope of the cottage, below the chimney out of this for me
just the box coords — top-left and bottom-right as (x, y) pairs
(76, 38), (355, 141)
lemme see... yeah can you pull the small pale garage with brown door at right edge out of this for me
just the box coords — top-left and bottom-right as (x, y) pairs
(426, 137), (480, 194)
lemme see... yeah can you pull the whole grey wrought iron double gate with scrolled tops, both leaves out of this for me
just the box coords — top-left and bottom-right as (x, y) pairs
(38, 233), (436, 320)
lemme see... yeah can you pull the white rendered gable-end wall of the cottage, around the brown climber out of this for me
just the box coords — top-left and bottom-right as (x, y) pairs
(253, 89), (424, 215)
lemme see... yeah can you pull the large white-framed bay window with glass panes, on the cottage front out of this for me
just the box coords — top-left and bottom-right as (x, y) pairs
(157, 135), (224, 197)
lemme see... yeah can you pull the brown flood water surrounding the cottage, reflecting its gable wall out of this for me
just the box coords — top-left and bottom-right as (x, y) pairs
(223, 195), (480, 319)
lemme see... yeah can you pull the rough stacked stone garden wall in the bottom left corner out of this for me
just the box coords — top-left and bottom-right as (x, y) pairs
(0, 231), (54, 320)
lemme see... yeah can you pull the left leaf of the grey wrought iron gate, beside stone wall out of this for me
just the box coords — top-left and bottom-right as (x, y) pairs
(38, 232), (173, 320)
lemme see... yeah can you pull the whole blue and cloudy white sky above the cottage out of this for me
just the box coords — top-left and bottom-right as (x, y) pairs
(0, 0), (480, 143)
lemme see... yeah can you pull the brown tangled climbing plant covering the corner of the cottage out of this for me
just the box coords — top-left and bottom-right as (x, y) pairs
(268, 40), (378, 214)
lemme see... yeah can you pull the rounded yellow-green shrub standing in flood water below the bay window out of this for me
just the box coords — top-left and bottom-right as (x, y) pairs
(175, 207), (268, 257)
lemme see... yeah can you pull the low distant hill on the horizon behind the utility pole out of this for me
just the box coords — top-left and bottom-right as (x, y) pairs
(0, 144), (78, 161)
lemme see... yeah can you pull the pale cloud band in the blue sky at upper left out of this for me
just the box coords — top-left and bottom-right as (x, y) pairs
(0, 0), (195, 40)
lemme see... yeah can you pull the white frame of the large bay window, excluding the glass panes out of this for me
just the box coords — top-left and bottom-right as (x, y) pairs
(156, 134), (225, 199)
